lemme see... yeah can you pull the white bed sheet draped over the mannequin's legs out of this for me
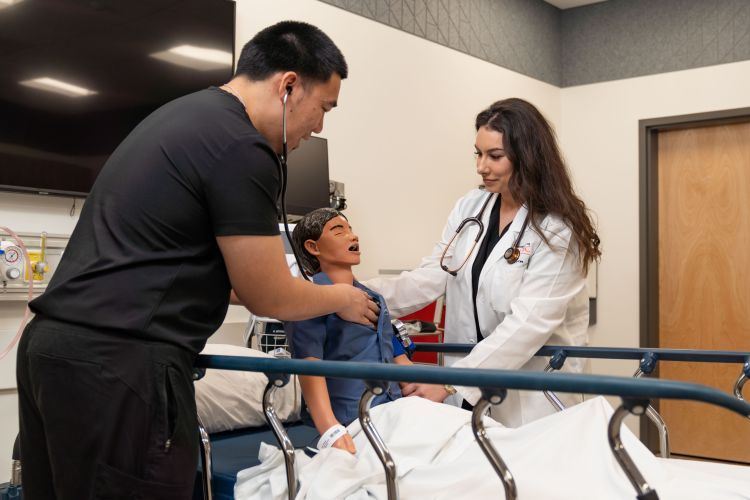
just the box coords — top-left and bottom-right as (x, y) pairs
(235, 398), (750, 500)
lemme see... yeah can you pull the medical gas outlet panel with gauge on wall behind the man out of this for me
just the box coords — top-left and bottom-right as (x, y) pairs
(0, 232), (68, 300)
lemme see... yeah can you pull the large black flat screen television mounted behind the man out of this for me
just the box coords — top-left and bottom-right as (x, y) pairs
(0, 0), (235, 197)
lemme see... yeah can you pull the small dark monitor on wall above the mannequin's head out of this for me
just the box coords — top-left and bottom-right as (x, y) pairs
(286, 137), (330, 216)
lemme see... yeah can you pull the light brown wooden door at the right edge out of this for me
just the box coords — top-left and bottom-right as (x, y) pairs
(658, 123), (750, 463)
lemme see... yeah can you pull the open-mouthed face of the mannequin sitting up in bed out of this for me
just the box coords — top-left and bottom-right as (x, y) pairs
(305, 215), (360, 272)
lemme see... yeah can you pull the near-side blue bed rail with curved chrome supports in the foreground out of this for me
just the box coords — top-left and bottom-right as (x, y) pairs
(196, 355), (750, 500)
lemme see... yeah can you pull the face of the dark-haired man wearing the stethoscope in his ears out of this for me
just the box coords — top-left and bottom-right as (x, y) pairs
(286, 73), (341, 151)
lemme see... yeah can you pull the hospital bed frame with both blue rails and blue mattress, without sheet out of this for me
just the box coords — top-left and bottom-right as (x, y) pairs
(192, 344), (750, 499)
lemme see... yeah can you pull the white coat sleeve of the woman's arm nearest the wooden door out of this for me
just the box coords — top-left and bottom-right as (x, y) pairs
(453, 221), (585, 404)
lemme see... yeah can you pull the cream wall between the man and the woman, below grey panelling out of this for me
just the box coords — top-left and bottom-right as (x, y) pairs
(237, 0), (560, 278)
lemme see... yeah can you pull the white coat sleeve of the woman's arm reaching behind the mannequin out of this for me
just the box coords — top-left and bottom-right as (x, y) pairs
(364, 198), (464, 318)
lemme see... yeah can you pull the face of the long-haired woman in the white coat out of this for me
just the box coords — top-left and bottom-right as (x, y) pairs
(474, 127), (513, 197)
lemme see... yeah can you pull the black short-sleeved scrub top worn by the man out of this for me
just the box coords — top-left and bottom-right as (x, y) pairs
(30, 87), (279, 353)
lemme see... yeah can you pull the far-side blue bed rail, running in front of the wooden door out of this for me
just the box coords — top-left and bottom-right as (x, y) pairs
(416, 342), (750, 458)
